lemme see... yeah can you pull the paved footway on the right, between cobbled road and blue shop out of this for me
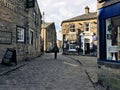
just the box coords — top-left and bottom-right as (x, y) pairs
(66, 55), (106, 90)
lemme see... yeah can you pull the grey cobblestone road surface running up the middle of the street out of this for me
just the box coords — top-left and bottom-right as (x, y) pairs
(0, 53), (94, 90)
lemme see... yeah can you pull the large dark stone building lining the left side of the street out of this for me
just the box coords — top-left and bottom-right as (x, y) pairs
(0, 0), (42, 61)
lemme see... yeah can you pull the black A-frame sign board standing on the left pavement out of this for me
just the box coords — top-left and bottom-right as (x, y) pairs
(2, 48), (17, 65)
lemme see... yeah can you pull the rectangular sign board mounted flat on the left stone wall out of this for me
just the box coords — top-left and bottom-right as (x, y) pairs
(0, 31), (12, 44)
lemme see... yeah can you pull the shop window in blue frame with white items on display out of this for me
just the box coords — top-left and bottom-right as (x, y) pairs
(106, 16), (120, 61)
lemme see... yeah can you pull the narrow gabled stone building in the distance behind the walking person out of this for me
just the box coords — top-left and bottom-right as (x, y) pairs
(41, 22), (57, 52)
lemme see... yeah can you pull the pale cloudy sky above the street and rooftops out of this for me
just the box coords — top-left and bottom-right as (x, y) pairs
(37, 0), (97, 40)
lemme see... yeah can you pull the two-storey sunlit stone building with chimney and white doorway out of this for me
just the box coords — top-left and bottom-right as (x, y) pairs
(61, 6), (97, 54)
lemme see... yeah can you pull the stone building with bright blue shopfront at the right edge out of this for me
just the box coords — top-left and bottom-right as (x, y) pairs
(97, 0), (120, 90)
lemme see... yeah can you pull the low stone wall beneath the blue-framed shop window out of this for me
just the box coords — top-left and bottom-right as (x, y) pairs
(98, 63), (120, 90)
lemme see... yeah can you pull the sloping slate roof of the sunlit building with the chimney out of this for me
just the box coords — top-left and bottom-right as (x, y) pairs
(62, 12), (97, 23)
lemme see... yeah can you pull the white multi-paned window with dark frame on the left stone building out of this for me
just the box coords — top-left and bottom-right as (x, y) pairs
(17, 26), (25, 43)
